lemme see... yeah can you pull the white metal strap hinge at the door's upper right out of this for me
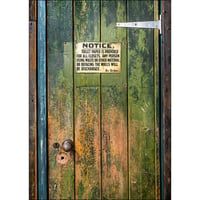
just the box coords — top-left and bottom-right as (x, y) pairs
(116, 15), (162, 34)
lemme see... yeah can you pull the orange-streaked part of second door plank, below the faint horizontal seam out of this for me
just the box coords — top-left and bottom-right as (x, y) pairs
(75, 87), (100, 199)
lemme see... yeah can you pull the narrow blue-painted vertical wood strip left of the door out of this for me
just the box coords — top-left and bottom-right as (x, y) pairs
(37, 1), (48, 199)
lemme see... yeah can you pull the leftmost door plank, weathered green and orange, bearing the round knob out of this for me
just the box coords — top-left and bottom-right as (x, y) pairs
(47, 1), (74, 199)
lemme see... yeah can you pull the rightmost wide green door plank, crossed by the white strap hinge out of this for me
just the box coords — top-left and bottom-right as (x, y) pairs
(127, 1), (158, 200)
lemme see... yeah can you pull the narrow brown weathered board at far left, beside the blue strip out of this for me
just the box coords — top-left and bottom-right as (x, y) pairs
(29, 21), (37, 200)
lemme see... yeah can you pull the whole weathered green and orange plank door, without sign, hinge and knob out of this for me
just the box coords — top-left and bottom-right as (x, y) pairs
(46, 0), (160, 200)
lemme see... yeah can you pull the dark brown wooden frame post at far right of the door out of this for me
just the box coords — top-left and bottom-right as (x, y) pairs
(162, 0), (171, 200)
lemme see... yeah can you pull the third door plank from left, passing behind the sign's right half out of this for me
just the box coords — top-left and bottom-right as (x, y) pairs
(101, 0), (128, 199)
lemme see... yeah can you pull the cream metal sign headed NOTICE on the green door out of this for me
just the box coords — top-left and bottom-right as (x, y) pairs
(75, 42), (121, 73)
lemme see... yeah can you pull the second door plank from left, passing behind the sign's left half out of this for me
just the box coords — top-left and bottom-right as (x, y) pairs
(74, 0), (101, 200)
